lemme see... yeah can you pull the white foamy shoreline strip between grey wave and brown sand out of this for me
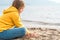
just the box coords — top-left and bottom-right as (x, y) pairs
(22, 21), (60, 29)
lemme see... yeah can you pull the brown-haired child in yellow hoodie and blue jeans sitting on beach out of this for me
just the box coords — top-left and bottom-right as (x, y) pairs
(0, 0), (36, 40)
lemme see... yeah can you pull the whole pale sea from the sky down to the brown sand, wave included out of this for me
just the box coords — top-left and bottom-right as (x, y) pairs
(0, 5), (60, 29)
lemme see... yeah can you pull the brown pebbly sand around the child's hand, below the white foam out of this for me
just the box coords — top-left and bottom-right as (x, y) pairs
(13, 28), (60, 40)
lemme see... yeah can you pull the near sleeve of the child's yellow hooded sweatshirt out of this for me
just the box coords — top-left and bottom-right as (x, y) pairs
(11, 13), (24, 27)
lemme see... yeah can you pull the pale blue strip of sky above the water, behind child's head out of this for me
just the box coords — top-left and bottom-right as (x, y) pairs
(0, 0), (60, 6)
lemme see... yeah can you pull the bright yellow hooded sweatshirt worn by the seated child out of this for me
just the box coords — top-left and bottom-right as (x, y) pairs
(0, 6), (24, 32)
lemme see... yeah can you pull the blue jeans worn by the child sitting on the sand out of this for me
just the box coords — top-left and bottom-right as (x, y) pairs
(0, 28), (26, 40)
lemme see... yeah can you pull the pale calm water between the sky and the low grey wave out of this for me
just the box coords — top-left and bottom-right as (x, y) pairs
(0, 5), (60, 23)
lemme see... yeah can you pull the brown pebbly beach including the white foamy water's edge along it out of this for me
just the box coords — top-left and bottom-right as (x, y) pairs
(13, 21), (60, 40)
